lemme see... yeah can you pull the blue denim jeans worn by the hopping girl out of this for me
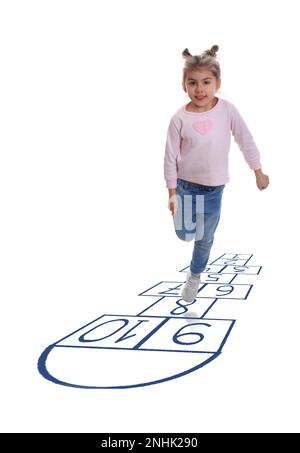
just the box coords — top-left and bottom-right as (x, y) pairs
(173, 178), (225, 274)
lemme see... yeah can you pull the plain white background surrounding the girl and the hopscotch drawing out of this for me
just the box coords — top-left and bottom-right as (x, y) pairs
(0, 0), (300, 433)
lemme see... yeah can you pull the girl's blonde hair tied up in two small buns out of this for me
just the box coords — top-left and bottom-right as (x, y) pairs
(182, 45), (221, 83)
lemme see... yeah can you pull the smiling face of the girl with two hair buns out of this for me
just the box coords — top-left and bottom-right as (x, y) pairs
(183, 68), (221, 112)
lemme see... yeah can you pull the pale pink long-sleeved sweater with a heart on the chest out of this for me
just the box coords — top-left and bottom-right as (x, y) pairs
(164, 98), (261, 189)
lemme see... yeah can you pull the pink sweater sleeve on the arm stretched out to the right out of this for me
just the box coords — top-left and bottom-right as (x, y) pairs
(231, 104), (261, 170)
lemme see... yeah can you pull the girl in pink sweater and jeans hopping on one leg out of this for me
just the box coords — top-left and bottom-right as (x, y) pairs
(164, 46), (269, 302)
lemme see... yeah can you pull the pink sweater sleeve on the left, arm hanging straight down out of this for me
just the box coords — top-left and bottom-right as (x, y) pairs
(164, 118), (181, 189)
